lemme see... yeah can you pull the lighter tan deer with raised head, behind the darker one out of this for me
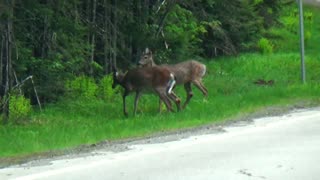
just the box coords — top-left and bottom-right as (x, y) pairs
(138, 48), (208, 109)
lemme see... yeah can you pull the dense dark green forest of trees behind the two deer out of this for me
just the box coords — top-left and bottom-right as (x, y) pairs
(0, 0), (282, 122)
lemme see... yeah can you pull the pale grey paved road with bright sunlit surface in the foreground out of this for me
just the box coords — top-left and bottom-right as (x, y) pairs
(0, 108), (320, 180)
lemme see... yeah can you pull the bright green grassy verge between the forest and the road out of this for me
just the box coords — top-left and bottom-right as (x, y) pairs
(0, 4), (320, 158)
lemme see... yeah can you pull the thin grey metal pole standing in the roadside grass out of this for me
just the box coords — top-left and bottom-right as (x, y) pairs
(297, 0), (306, 84)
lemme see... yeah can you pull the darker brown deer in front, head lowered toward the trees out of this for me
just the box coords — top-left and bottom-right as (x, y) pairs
(112, 64), (180, 117)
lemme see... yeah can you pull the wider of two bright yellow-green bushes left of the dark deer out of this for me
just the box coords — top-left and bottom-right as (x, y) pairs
(66, 76), (98, 99)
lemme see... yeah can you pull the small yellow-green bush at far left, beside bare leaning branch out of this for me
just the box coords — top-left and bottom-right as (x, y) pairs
(9, 94), (32, 123)
